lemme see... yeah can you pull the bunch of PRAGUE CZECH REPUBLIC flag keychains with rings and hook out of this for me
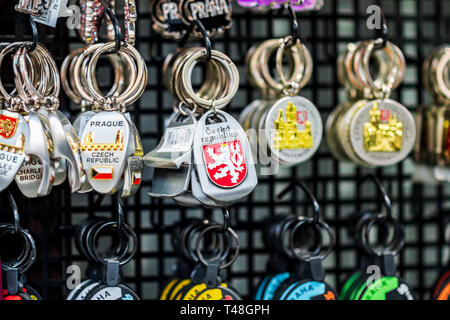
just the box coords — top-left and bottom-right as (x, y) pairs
(73, 9), (148, 197)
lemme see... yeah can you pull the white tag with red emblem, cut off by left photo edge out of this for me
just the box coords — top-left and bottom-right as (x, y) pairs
(0, 110), (30, 191)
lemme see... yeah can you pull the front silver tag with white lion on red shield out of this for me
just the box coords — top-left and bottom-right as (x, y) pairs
(193, 110), (258, 202)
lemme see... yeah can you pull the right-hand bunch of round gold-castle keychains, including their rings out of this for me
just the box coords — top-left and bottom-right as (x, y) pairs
(326, 15), (416, 167)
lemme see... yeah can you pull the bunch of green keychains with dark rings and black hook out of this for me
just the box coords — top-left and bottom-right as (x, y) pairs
(340, 175), (414, 300)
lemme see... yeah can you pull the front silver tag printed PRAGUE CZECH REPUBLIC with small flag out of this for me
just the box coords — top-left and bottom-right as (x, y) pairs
(80, 111), (131, 194)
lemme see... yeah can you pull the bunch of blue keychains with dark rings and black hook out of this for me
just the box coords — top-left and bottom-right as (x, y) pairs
(255, 182), (337, 300)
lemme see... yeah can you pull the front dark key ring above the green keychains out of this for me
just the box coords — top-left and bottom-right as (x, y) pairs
(360, 213), (405, 257)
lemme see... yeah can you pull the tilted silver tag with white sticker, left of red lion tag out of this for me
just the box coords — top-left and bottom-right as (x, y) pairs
(144, 112), (197, 169)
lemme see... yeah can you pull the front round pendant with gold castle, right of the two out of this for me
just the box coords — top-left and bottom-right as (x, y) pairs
(349, 99), (416, 166)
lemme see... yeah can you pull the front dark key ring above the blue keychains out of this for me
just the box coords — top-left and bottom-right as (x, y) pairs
(289, 217), (336, 262)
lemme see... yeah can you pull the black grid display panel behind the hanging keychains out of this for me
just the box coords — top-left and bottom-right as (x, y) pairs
(0, 0), (450, 299)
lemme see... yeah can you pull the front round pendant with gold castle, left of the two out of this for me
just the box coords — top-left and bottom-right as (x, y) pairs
(265, 96), (322, 166)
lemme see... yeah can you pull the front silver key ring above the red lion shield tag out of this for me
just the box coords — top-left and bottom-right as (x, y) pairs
(180, 49), (239, 109)
